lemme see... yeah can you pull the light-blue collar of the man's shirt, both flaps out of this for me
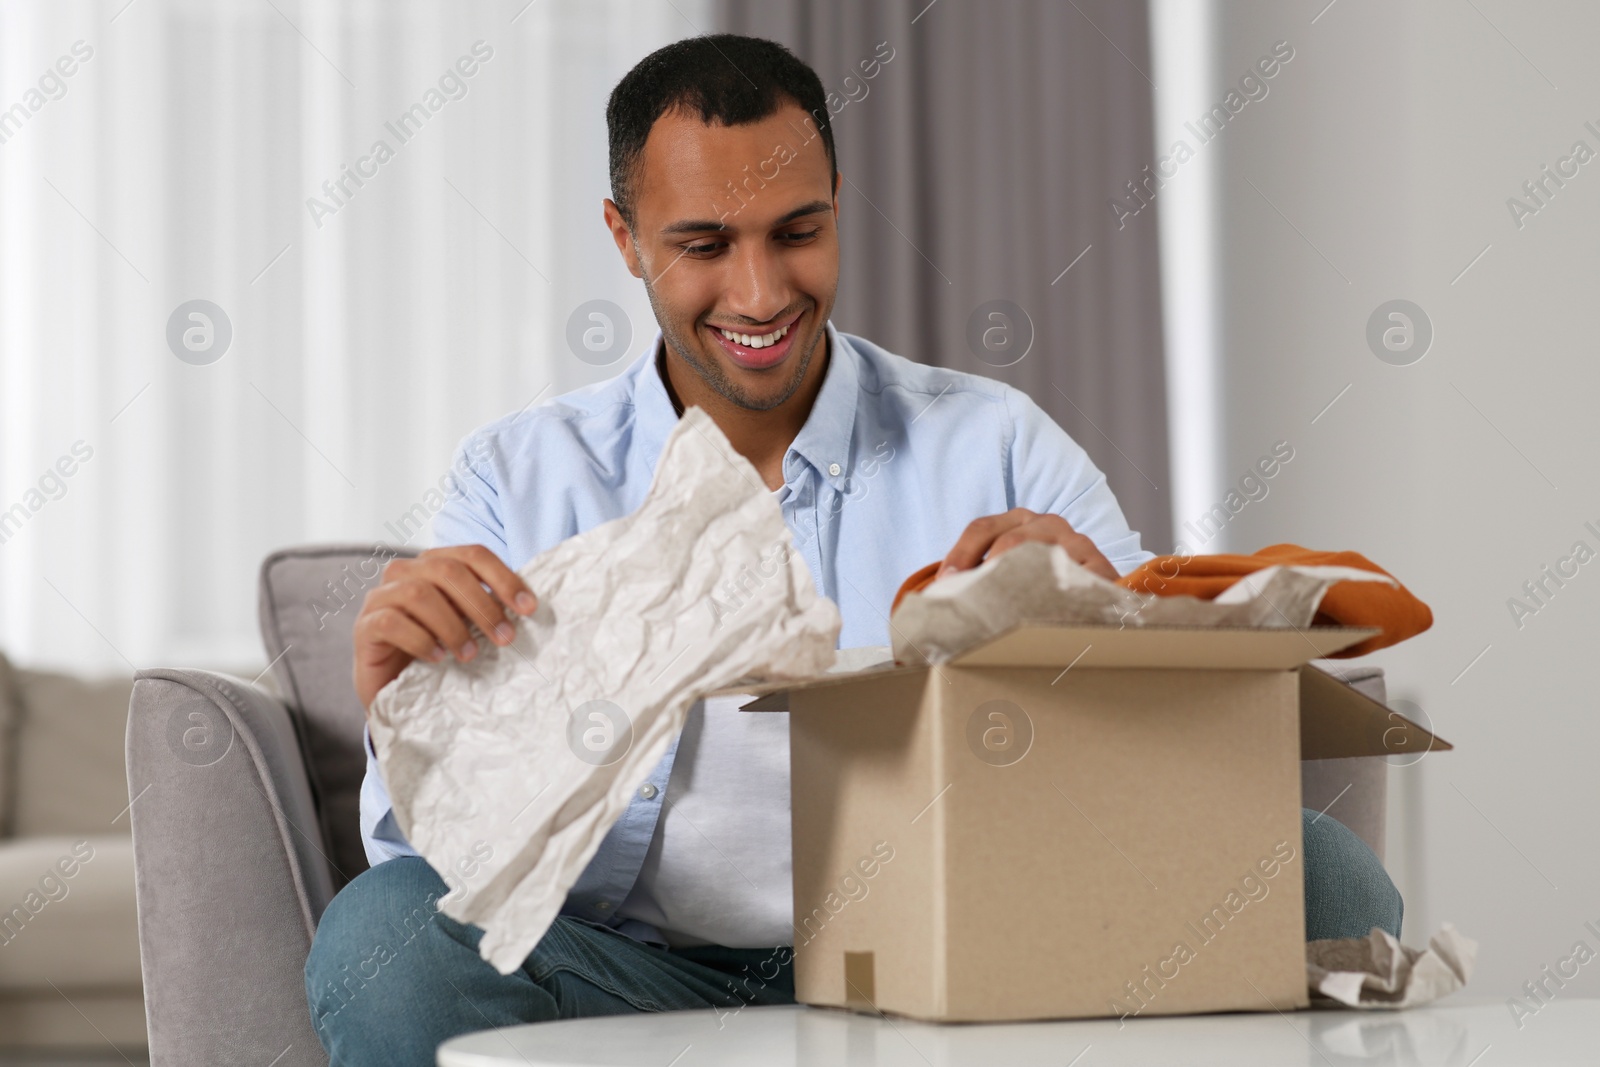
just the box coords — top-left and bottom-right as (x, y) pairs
(629, 322), (861, 488)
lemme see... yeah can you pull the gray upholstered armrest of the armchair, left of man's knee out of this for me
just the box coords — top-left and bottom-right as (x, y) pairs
(128, 669), (333, 1067)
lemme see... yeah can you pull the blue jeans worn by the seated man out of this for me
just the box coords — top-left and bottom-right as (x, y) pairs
(306, 811), (1403, 1067)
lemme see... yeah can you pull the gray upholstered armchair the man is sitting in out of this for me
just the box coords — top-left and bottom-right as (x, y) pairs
(128, 544), (1387, 1067)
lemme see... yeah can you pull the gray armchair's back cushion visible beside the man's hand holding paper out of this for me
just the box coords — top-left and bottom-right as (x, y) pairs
(259, 544), (416, 889)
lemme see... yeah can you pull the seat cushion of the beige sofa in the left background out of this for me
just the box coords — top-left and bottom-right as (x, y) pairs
(0, 831), (141, 993)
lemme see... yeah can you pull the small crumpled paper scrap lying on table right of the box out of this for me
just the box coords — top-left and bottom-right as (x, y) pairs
(1306, 923), (1478, 1011)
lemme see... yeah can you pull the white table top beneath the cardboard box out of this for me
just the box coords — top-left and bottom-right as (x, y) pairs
(438, 998), (1600, 1067)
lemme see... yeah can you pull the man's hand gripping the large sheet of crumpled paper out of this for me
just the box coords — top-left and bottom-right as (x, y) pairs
(355, 544), (539, 707)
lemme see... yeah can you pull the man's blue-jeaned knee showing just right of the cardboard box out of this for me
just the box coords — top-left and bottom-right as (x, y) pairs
(1301, 808), (1405, 941)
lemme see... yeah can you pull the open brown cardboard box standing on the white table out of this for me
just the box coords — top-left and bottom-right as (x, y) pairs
(726, 624), (1450, 1021)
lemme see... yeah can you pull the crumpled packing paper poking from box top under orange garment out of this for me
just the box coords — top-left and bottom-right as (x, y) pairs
(890, 542), (1395, 664)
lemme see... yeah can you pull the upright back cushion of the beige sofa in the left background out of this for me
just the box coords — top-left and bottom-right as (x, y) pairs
(10, 669), (133, 838)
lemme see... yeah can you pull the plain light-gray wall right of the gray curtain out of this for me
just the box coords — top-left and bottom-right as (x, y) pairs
(1157, 0), (1600, 1004)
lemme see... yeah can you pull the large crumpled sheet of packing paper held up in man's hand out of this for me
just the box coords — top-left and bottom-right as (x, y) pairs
(370, 408), (840, 974)
